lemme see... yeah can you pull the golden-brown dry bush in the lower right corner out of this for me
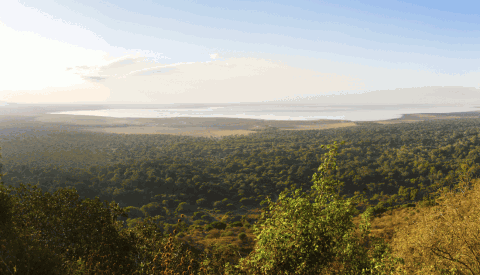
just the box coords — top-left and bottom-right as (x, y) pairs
(392, 180), (480, 274)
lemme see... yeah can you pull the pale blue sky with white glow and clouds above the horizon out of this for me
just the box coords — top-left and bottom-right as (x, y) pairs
(0, 0), (480, 104)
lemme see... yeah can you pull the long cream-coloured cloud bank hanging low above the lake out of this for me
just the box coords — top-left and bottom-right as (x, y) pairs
(74, 57), (363, 103)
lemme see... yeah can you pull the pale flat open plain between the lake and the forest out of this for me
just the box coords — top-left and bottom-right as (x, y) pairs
(18, 112), (480, 138)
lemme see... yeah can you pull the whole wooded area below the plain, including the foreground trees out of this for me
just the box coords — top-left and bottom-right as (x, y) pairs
(0, 118), (480, 274)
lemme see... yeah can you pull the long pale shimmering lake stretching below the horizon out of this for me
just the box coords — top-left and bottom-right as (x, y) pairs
(50, 103), (480, 121)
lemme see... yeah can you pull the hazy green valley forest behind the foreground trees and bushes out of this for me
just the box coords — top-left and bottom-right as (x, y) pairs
(4, 119), (480, 226)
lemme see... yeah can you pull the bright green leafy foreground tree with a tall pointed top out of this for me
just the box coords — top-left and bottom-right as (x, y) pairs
(236, 142), (382, 274)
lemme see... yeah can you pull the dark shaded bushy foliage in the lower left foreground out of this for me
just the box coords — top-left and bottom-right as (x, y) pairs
(1, 185), (133, 274)
